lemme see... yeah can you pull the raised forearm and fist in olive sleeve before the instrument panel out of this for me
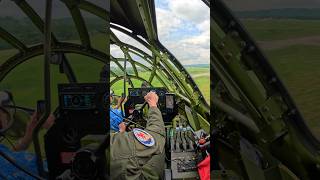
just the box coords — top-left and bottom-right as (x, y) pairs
(145, 92), (165, 135)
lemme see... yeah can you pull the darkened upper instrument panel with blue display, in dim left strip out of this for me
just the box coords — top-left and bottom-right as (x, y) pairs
(58, 83), (108, 134)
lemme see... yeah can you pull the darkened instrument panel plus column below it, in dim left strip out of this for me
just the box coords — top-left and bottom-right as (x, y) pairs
(45, 83), (109, 179)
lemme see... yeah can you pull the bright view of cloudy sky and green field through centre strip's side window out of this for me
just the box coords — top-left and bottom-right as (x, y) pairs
(155, 0), (210, 103)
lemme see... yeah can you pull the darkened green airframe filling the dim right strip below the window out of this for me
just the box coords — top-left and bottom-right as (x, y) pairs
(214, 0), (320, 180)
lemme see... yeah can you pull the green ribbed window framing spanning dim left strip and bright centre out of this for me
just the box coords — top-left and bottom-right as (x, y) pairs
(0, 0), (210, 179)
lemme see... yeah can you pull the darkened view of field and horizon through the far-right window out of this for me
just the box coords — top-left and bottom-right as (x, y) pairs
(224, 0), (320, 139)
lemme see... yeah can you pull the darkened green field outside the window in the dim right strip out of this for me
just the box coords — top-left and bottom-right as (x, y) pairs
(243, 19), (320, 139)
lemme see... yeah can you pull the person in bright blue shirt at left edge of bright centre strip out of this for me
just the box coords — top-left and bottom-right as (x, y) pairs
(110, 90), (126, 132)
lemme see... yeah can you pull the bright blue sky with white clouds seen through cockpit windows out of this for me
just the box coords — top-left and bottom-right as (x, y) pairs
(110, 0), (210, 65)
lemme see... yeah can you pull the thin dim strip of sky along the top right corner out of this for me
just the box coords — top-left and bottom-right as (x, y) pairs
(223, 0), (320, 10)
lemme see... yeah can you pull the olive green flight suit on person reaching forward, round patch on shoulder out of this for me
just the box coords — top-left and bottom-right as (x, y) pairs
(110, 107), (165, 180)
